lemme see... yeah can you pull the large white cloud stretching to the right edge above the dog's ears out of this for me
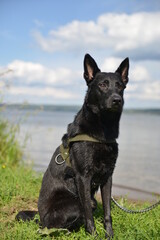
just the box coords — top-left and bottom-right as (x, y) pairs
(34, 12), (160, 57)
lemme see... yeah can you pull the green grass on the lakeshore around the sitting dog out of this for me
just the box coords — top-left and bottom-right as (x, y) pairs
(0, 115), (160, 240)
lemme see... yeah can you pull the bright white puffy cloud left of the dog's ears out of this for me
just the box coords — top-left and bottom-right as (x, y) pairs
(5, 60), (80, 86)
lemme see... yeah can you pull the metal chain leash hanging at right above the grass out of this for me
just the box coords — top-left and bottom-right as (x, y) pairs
(111, 197), (160, 214)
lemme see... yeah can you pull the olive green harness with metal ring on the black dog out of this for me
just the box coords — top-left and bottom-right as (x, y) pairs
(55, 134), (116, 167)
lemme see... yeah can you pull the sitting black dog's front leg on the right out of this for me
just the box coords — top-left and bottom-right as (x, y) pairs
(101, 176), (113, 239)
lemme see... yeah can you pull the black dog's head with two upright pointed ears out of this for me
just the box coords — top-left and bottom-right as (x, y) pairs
(84, 54), (129, 113)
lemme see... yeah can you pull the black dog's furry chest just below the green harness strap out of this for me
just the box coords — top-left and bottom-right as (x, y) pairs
(70, 142), (118, 185)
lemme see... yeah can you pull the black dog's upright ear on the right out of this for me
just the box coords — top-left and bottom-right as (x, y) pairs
(116, 58), (129, 85)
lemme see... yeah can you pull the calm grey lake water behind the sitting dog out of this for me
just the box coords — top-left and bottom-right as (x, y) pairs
(3, 105), (160, 201)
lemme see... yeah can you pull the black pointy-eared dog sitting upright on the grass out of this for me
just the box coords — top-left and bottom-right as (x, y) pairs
(15, 54), (129, 239)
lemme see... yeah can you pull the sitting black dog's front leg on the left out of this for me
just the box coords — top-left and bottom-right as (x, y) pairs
(76, 176), (95, 234)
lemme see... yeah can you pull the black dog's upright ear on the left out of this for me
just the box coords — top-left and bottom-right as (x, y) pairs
(83, 54), (100, 85)
